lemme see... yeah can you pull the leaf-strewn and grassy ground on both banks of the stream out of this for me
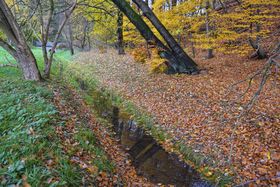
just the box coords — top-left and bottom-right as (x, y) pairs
(0, 49), (280, 186)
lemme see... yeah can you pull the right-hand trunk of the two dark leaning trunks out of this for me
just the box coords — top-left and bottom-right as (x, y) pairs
(133, 0), (198, 71)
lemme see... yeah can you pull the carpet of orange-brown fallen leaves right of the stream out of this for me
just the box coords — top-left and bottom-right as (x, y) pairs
(72, 50), (280, 186)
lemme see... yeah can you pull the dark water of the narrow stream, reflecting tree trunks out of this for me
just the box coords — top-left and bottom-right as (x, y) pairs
(112, 108), (212, 187)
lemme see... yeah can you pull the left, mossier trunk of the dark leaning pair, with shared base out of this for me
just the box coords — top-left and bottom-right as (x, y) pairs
(112, 0), (198, 74)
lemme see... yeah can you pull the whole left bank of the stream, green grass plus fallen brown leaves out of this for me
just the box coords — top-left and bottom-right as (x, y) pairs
(0, 49), (152, 187)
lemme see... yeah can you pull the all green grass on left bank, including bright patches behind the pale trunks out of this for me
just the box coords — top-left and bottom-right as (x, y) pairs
(0, 48), (114, 186)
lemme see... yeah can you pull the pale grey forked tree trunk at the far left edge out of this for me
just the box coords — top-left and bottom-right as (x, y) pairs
(0, 0), (41, 81)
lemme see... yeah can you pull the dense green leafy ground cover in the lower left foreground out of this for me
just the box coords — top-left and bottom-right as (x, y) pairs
(0, 78), (76, 186)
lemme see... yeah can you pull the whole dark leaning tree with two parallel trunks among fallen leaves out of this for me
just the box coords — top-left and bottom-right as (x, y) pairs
(112, 0), (199, 74)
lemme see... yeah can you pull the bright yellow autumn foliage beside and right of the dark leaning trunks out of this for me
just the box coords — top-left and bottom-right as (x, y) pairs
(125, 0), (280, 56)
